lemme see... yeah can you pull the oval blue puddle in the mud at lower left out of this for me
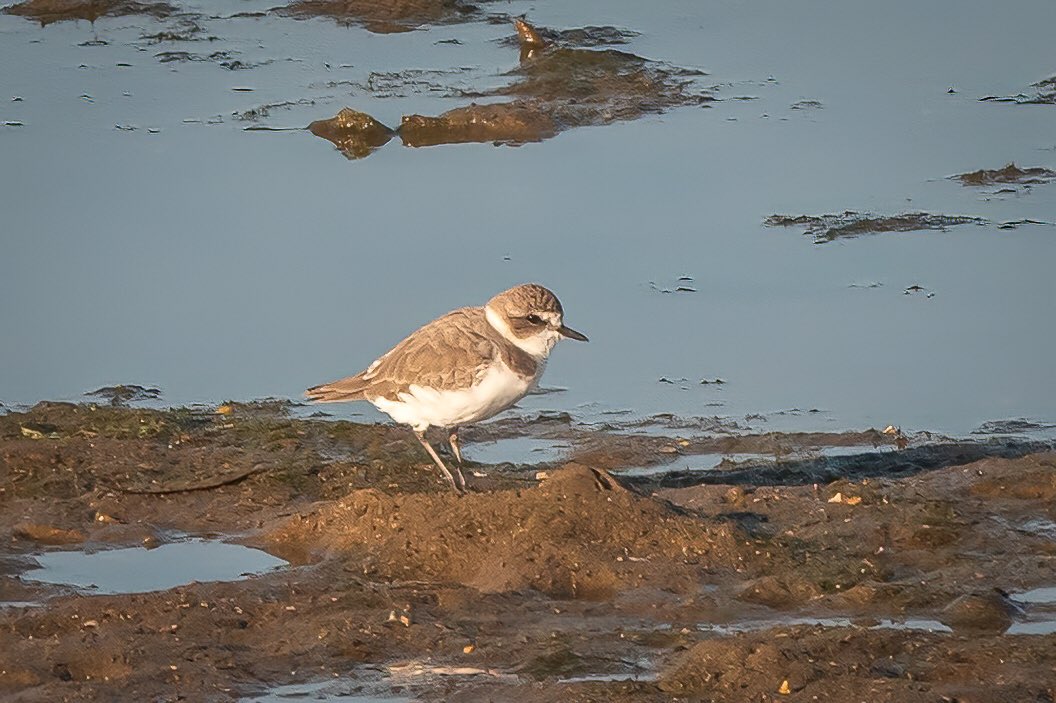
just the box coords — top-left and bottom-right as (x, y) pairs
(21, 539), (287, 594)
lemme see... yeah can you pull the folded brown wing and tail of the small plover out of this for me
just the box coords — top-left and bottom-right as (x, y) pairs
(305, 307), (499, 402)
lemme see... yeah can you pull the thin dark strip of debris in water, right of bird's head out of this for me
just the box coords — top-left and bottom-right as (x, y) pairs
(763, 210), (988, 244)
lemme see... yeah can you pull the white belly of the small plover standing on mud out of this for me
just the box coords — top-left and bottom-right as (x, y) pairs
(370, 363), (542, 431)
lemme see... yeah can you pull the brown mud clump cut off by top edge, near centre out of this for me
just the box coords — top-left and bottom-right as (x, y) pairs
(279, 0), (483, 34)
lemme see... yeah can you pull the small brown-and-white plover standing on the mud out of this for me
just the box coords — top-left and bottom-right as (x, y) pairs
(305, 283), (587, 494)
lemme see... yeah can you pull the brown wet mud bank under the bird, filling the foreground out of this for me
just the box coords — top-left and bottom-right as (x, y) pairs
(0, 401), (1056, 702)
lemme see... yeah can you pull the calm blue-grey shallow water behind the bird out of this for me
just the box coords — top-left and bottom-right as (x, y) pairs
(0, 0), (1056, 435)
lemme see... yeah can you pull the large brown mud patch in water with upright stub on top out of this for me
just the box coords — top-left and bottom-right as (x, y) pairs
(308, 20), (713, 158)
